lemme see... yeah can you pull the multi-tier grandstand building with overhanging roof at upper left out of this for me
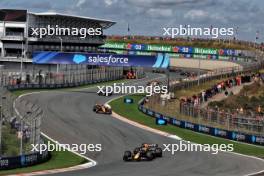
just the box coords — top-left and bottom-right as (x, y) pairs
(0, 9), (115, 64)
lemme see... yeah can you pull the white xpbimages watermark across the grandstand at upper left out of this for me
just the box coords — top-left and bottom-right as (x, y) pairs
(30, 25), (103, 38)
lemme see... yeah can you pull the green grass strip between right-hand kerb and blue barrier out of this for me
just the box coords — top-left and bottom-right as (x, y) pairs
(110, 95), (264, 158)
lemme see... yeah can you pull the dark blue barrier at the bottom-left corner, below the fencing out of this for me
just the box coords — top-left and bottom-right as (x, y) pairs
(0, 150), (51, 170)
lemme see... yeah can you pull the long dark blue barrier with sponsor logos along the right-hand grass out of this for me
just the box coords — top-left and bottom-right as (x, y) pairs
(138, 99), (264, 146)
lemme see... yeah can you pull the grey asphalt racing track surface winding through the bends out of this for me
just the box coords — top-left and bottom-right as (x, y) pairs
(20, 74), (264, 176)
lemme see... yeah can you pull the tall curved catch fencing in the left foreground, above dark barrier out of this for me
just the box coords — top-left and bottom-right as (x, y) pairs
(0, 87), (48, 162)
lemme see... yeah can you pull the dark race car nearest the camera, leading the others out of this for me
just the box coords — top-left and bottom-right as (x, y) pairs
(123, 143), (162, 161)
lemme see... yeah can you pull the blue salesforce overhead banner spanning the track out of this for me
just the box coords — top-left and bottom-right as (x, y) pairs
(33, 51), (169, 68)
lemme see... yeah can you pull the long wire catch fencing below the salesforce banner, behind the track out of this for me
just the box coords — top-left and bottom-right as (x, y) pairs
(0, 67), (123, 89)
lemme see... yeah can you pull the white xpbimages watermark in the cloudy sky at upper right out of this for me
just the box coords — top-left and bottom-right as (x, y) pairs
(163, 25), (234, 39)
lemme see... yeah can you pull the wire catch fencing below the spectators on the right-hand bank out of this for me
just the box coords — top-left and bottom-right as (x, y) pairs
(180, 103), (264, 136)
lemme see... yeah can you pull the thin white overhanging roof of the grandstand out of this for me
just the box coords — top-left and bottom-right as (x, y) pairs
(31, 12), (116, 29)
